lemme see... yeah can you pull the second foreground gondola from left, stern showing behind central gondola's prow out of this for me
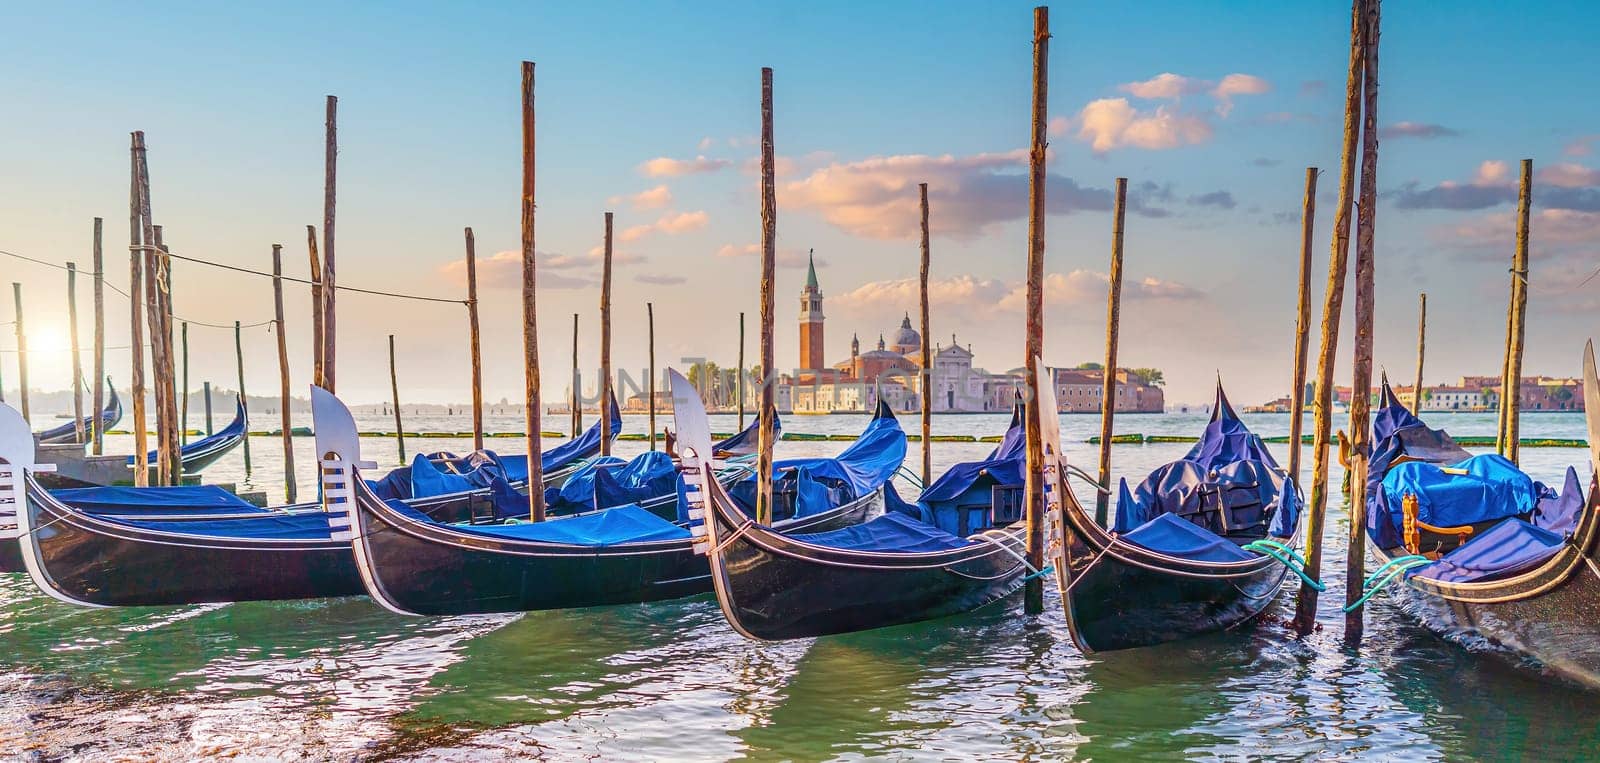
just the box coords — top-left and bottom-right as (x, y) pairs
(331, 380), (906, 614)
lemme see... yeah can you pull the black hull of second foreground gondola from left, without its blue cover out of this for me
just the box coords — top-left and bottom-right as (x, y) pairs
(355, 488), (882, 614)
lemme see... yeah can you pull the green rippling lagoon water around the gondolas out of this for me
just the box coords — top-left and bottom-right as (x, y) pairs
(0, 407), (1600, 760)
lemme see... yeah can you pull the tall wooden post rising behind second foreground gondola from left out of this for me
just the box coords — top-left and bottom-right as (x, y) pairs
(522, 61), (544, 521)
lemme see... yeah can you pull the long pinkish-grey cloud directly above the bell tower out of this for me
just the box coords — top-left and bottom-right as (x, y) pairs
(779, 149), (1168, 238)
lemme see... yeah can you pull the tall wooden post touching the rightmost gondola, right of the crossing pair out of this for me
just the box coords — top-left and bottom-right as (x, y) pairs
(1344, 0), (1382, 645)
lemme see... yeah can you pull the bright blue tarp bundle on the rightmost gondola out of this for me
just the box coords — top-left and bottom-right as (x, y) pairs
(1378, 453), (1541, 537)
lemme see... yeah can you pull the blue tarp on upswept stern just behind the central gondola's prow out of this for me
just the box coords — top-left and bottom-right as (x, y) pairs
(728, 400), (906, 518)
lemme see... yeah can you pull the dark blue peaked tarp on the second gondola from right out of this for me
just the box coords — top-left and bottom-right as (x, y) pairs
(1112, 385), (1299, 537)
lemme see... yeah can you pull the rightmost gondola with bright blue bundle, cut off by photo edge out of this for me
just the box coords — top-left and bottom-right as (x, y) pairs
(1366, 342), (1600, 689)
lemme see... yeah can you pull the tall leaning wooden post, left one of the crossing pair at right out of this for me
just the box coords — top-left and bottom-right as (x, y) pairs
(1294, 0), (1362, 635)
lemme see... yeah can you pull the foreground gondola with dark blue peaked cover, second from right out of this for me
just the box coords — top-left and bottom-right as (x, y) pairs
(1051, 382), (1301, 653)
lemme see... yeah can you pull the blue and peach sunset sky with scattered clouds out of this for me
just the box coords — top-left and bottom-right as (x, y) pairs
(0, 2), (1600, 405)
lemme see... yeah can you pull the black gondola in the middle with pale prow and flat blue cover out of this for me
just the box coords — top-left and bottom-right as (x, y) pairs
(670, 371), (1026, 640)
